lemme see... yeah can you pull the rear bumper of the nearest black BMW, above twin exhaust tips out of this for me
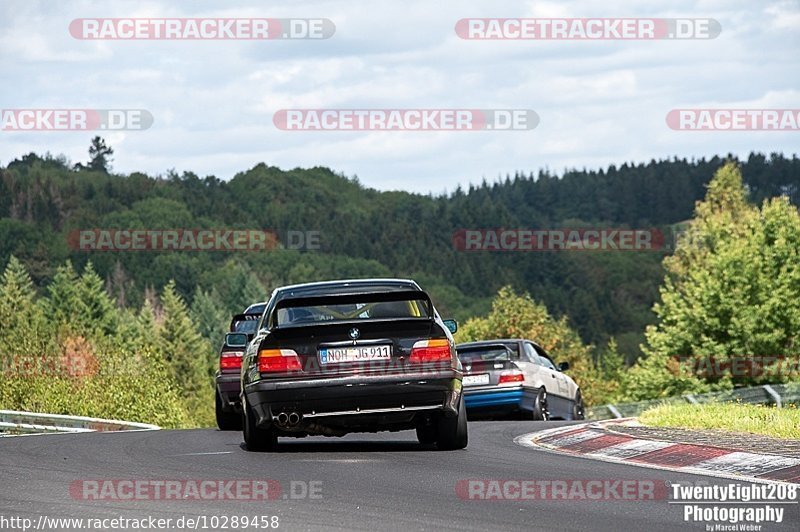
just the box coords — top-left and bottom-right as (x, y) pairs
(245, 370), (461, 429)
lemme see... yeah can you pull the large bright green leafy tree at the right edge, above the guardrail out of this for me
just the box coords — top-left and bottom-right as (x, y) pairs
(629, 163), (800, 398)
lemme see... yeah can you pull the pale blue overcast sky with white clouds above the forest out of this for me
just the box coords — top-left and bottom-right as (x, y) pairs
(0, 0), (800, 193)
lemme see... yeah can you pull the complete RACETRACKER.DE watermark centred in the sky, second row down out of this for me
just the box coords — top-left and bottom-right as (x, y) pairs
(272, 109), (539, 131)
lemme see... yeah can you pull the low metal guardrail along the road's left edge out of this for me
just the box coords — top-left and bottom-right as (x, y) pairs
(0, 410), (160, 436)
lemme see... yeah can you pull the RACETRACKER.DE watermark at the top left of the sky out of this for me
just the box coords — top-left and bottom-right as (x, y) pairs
(69, 17), (336, 41)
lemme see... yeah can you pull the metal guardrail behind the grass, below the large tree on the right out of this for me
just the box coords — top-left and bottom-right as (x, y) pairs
(586, 383), (800, 419)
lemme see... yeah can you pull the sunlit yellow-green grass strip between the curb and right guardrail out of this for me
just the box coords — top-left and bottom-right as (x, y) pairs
(639, 403), (800, 439)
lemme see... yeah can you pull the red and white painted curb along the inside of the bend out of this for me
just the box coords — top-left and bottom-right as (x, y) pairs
(514, 419), (800, 484)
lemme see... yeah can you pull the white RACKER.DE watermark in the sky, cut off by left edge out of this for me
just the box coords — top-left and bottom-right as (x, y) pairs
(0, 108), (153, 131)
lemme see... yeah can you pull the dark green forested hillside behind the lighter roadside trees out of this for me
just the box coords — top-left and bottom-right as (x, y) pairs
(0, 147), (800, 363)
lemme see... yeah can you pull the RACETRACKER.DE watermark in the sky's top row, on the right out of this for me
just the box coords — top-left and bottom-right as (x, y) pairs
(455, 17), (722, 41)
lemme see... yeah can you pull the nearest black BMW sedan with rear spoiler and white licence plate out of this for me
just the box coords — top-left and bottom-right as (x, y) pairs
(241, 279), (467, 451)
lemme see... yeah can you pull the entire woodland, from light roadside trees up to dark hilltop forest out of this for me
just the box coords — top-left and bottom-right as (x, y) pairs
(0, 143), (800, 427)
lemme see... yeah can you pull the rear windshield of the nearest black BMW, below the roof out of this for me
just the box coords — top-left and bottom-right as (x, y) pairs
(276, 299), (430, 326)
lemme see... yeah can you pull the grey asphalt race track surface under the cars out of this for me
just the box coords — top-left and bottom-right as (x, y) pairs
(0, 421), (800, 532)
